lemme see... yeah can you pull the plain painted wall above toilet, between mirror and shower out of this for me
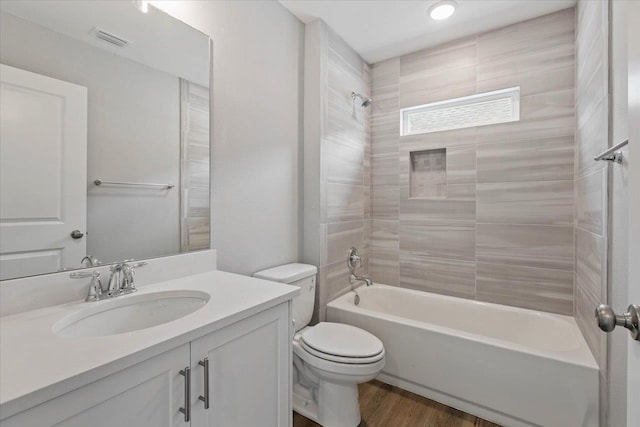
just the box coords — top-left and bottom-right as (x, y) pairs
(152, 1), (304, 274)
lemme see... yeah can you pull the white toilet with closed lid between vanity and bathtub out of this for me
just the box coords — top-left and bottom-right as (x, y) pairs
(253, 263), (385, 427)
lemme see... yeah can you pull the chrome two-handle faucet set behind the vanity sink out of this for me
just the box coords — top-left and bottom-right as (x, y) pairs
(69, 262), (147, 302)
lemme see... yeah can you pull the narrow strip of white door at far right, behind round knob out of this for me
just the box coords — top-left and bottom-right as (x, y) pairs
(627, 2), (640, 426)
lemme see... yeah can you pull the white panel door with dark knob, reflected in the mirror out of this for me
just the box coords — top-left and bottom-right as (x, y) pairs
(0, 61), (87, 279)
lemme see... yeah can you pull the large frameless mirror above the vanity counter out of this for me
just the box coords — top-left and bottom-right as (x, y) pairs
(0, 0), (211, 279)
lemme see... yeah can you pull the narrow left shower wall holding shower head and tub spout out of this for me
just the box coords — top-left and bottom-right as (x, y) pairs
(303, 21), (371, 321)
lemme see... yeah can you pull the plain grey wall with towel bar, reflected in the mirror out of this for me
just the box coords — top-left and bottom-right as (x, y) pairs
(0, 13), (180, 265)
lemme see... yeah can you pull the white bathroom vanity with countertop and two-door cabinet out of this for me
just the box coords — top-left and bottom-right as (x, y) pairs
(0, 262), (299, 427)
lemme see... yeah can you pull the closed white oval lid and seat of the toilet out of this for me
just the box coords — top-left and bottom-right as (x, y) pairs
(300, 322), (384, 364)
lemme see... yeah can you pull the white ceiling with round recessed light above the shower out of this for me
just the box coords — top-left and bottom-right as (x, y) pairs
(279, 0), (576, 64)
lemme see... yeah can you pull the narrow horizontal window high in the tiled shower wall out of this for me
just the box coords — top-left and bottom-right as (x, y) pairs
(400, 87), (520, 135)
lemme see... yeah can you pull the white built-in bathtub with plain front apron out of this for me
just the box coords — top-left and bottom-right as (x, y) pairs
(327, 284), (599, 427)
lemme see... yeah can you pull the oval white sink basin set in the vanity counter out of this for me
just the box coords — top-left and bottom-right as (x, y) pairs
(53, 291), (209, 338)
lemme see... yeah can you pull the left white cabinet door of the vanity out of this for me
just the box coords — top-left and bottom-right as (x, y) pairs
(2, 344), (189, 427)
